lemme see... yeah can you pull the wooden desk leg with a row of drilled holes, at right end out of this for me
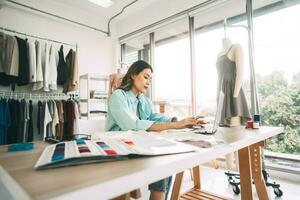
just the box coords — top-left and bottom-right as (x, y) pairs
(250, 142), (269, 200)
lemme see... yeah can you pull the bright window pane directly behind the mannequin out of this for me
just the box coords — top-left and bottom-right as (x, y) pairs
(194, 1), (250, 120)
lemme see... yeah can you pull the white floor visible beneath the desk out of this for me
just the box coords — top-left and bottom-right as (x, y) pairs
(141, 168), (300, 200)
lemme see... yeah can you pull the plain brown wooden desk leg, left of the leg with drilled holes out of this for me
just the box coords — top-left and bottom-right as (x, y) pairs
(238, 147), (253, 200)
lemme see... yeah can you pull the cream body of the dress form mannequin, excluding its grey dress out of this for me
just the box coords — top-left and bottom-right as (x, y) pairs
(218, 37), (244, 171)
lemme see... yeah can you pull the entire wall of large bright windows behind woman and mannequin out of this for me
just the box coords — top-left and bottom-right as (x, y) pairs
(120, 0), (300, 159)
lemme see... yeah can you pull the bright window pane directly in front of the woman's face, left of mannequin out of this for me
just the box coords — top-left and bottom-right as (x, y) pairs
(154, 18), (191, 117)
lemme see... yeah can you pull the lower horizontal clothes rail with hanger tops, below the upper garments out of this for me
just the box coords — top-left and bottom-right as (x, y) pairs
(0, 91), (79, 100)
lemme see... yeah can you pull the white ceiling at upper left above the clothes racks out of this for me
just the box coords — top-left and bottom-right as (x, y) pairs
(5, 0), (158, 28)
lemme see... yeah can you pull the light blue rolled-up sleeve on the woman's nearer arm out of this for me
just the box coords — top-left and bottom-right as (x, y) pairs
(108, 92), (154, 131)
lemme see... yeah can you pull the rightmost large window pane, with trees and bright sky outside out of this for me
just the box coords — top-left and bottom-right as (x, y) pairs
(253, 4), (300, 155)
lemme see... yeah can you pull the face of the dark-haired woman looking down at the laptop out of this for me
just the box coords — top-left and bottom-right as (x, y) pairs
(131, 68), (152, 94)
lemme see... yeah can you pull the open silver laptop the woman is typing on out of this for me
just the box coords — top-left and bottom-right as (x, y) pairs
(193, 91), (224, 135)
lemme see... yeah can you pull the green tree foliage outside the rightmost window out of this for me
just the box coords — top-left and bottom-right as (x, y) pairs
(257, 72), (300, 155)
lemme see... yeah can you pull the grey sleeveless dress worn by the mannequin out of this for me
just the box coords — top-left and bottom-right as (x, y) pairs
(217, 46), (251, 126)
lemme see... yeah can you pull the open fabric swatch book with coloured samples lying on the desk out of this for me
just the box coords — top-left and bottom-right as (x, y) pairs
(35, 133), (198, 169)
